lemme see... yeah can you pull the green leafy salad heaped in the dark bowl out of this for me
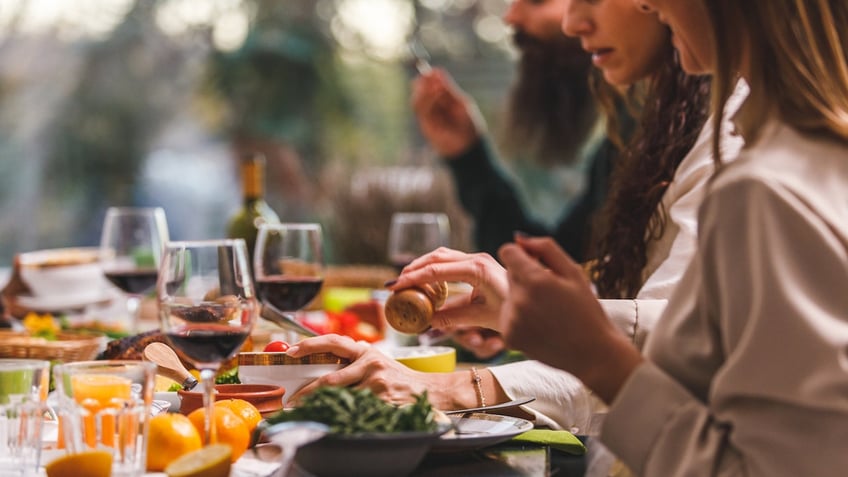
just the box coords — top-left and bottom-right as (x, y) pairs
(266, 386), (437, 434)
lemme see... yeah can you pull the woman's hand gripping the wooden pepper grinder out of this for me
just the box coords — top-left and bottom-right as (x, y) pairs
(389, 247), (508, 330)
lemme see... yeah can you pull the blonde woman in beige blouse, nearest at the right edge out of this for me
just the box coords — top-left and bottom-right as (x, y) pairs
(500, 0), (848, 477)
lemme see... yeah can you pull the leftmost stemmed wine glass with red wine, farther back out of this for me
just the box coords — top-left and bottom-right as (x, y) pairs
(100, 207), (168, 333)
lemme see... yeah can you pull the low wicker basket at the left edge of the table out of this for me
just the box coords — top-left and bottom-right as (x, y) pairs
(0, 331), (103, 362)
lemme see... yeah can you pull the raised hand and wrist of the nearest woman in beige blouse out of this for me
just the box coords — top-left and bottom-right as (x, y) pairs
(499, 237), (642, 403)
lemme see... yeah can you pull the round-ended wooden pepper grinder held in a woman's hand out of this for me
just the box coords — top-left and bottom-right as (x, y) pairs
(385, 282), (448, 334)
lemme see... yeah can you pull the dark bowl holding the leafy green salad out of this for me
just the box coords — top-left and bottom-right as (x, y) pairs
(295, 425), (450, 477)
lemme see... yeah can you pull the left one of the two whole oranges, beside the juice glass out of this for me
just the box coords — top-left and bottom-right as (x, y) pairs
(147, 413), (203, 472)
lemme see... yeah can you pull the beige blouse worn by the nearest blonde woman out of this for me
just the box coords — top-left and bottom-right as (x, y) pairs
(601, 116), (848, 477)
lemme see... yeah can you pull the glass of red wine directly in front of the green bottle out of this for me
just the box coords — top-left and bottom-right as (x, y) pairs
(253, 223), (324, 332)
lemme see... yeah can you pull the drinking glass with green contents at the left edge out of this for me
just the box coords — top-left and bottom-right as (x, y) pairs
(0, 359), (50, 477)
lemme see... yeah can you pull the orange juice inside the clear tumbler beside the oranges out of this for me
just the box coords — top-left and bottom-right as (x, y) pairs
(71, 374), (132, 448)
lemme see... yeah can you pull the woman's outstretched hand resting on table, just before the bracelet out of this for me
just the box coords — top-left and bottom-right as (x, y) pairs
(287, 335), (450, 409)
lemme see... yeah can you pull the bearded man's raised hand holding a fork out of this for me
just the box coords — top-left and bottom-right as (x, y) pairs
(412, 68), (485, 158)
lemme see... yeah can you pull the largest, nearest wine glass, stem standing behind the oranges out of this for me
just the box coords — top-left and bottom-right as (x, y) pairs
(156, 239), (259, 444)
